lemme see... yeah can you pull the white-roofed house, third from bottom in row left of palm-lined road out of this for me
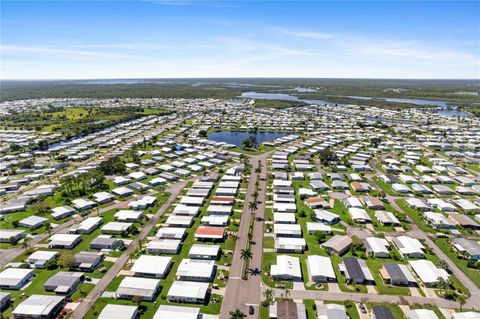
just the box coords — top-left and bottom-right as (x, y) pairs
(175, 259), (215, 281)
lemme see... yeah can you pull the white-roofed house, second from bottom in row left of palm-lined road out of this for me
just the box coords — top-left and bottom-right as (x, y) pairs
(167, 280), (209, 303)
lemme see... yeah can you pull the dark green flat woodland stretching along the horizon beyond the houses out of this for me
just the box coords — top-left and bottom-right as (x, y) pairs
(0, 78), (480, 114)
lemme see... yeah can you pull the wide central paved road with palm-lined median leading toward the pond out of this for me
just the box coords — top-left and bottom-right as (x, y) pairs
(220, 153), (270, 318)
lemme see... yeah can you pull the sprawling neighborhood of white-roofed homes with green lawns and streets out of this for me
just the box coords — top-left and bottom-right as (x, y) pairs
(0, 95), (480, 319)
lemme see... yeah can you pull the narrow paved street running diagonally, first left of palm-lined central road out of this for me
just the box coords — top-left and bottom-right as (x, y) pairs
(71, 180), (189, 319)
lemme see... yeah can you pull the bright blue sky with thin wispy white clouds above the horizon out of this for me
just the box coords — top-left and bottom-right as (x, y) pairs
(0, 0), (480, 79)
